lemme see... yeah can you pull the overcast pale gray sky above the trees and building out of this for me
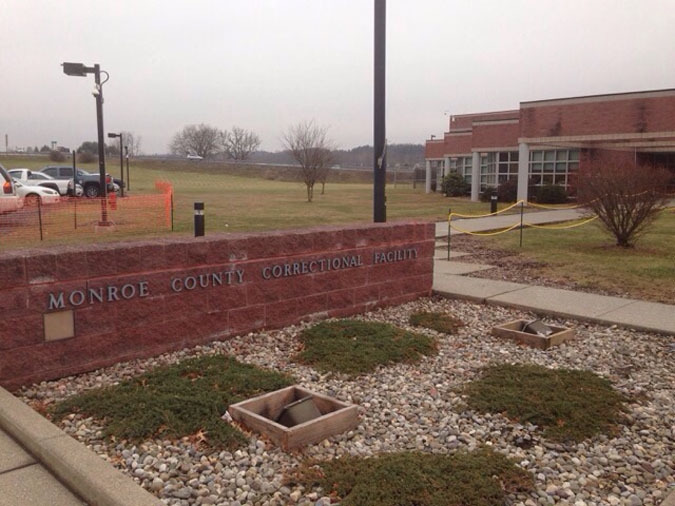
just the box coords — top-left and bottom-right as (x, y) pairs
(0, 0), (675, 153)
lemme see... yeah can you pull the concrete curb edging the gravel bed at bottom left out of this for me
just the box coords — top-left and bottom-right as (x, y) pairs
(0, 387), (163, 506)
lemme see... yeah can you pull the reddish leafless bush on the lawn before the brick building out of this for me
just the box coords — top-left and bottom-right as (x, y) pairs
(578, 161), (672, 248)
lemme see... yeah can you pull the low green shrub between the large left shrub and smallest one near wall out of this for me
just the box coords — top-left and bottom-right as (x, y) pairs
(295, 320), (436, 375)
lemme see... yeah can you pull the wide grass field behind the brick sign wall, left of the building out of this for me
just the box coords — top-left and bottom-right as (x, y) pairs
(0, 156), (496, 241)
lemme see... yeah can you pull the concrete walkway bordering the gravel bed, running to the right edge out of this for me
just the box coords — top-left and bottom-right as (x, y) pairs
(433, 258), (675, 335)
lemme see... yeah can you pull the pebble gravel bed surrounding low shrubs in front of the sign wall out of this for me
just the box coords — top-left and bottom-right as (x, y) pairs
(18, 299), (675, 506)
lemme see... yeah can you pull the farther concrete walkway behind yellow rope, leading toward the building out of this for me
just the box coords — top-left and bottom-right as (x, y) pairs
(436, 209), (584, 237)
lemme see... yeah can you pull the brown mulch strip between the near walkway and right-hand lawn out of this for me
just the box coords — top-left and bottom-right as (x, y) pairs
(443, 234), (672, 304)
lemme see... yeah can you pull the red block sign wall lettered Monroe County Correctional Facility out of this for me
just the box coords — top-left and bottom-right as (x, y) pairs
(0, 222), (434, 388)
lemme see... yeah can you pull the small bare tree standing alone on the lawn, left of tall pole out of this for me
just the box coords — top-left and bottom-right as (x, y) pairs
(282, 121), (333, 202)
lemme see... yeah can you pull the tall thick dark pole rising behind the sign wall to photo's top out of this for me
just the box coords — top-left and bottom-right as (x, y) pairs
(373, 0), (387, 223)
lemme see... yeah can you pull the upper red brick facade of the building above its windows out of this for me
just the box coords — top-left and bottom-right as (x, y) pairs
(425, 90), (675, 160)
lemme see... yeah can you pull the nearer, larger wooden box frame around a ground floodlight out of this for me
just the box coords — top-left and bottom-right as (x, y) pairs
(227, 385), (359, 450)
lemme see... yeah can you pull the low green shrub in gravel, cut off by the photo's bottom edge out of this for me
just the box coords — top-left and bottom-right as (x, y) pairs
(298, 448), (533, 506)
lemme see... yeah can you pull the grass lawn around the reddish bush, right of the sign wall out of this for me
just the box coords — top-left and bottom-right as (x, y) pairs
(480, 211), (675, 304)
